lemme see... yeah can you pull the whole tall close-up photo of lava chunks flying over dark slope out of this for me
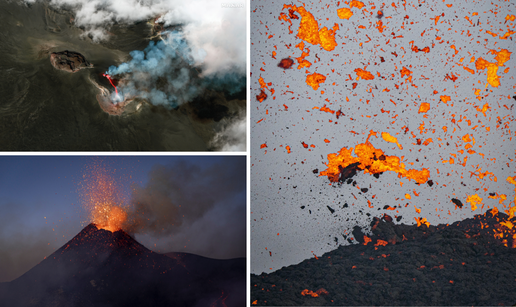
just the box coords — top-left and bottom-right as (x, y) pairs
(249, 0), (516, 306)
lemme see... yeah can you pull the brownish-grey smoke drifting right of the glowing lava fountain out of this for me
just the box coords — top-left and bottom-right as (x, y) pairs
(124, 156), (246, 258)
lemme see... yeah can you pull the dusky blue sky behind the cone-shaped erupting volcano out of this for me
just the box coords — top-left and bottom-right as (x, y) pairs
(0, 156), (246, 282)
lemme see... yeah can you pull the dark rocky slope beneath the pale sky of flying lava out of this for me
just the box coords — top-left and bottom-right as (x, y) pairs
(251, 213), (516, 306)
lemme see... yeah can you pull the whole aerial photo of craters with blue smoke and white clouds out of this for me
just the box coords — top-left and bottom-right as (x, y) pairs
(0, 0), (246, 151)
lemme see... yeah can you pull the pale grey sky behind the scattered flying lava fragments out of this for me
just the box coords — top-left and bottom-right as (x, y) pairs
(251, 0), (516, 274)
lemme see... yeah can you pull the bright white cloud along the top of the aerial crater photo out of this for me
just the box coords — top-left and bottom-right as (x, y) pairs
(26, 0), (247, 75)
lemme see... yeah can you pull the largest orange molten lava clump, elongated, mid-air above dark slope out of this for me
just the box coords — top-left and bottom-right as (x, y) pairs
(319, 141), (430, 184)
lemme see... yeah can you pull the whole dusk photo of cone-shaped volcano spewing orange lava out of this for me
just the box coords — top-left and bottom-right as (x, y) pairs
(0, 157), (247, 307)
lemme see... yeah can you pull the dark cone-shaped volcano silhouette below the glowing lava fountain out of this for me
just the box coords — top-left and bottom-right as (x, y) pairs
(0, 224), (245, 306)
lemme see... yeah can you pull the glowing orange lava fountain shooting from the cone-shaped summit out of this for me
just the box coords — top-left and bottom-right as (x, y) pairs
(82, 165), (127, 232)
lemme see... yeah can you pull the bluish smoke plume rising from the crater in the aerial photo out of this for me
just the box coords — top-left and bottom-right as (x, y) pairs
(107, 31), (245, 108)
